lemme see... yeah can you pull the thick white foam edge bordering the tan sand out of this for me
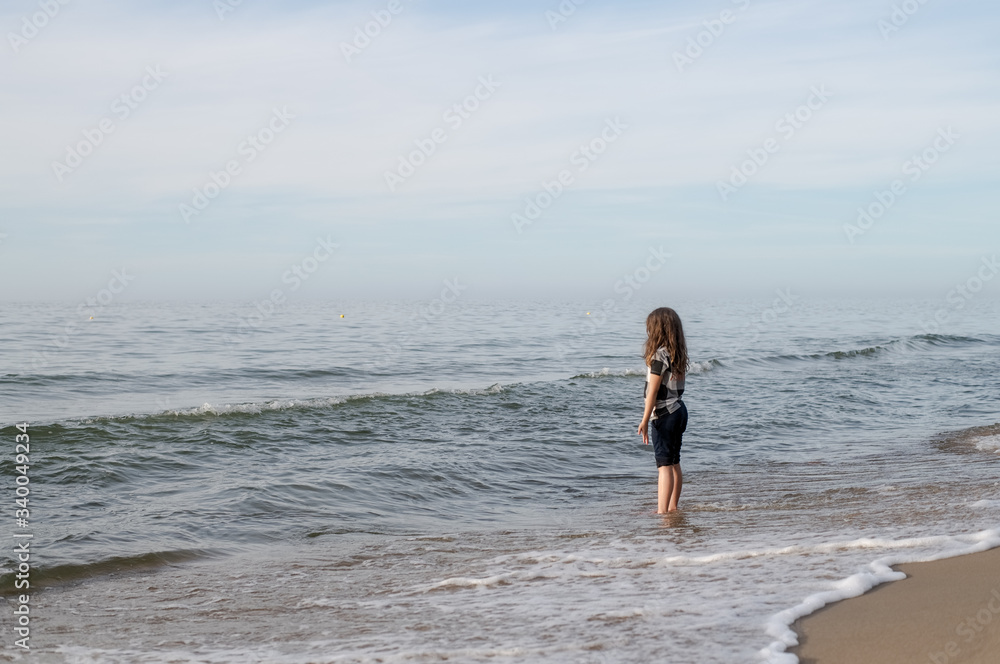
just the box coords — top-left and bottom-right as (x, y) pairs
(760, 529), (1000, 664)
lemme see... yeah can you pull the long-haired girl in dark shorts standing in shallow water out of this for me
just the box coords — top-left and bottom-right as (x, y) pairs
(639, 307), (687, 514)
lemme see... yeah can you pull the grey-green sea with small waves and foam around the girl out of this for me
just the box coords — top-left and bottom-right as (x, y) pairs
(0, 298), (1000, 664)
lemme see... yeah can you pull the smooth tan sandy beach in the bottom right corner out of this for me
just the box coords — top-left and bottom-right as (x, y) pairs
(793, 549), (1000, 664)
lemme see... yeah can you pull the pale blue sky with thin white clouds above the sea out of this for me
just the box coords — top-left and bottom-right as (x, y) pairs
(0, 0), (1000, 302)
